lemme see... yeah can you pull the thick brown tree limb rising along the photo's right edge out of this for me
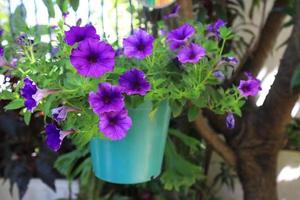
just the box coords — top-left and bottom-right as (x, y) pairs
(260, 1), (300, 134)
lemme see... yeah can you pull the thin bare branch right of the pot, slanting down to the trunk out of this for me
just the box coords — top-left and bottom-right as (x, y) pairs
(195, 114), (236, 167)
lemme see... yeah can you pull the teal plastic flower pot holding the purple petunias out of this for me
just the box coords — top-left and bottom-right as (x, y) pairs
(90, 102), (170, 184)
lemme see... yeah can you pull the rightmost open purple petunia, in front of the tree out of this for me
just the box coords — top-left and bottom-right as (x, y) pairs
(238, 73), (261, 97)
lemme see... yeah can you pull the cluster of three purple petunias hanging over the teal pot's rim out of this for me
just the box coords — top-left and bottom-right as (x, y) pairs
(89, 68), (150, 140)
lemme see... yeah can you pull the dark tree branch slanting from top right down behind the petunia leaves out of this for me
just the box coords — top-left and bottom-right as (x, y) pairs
(232, 0), (289, 81)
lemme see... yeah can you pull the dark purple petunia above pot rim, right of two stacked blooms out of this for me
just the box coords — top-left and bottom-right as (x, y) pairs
(119, 68), (151, 96)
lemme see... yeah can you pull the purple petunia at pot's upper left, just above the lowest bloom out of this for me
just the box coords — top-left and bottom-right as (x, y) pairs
(89, 83), (125, 115)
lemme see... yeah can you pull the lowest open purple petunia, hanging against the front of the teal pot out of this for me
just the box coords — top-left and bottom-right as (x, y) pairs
(99, 108), (132, 140)
